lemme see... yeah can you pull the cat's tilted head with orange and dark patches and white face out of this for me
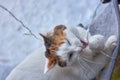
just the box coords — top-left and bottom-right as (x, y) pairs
(40, 25), (84, 73)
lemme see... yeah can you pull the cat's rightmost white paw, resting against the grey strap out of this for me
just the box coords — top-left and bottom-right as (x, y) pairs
(105, 35), (117, 51)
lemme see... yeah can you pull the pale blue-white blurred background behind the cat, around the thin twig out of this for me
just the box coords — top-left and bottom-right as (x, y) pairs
(0, 0), (99, 80)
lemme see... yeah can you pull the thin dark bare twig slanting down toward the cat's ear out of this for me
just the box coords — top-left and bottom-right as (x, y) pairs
(0, 4), (39, 39)
